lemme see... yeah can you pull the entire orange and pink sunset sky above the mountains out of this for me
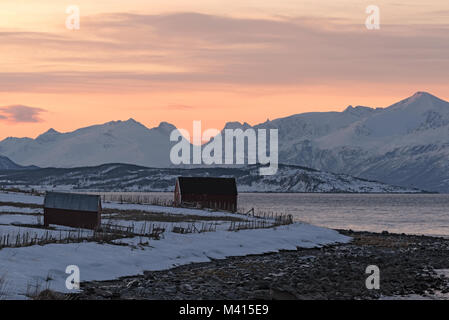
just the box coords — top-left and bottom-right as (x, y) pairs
(0, 0), (449, 139)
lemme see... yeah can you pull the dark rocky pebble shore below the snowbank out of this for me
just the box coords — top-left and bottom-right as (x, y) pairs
(72, 230), (449, 300)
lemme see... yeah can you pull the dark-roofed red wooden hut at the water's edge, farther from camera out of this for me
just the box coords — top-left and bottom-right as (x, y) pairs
(174, 177), (237, 212)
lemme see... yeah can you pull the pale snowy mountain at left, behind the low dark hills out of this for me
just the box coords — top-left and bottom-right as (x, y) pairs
(0, 119), (180, 168)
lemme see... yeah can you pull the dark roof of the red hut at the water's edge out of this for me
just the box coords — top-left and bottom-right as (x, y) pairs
(178, 177), (237, 195)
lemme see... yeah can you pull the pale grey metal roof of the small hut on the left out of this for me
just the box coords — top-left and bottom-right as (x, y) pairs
(44, 192), (101, 212)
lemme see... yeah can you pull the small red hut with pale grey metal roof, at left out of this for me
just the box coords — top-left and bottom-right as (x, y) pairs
(44, 192), (101, 230)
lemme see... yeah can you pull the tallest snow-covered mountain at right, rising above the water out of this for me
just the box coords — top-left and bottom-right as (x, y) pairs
(252, 92), (449, 192)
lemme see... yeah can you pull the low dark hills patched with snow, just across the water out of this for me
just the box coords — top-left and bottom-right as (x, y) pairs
(0, 164), (420, 193)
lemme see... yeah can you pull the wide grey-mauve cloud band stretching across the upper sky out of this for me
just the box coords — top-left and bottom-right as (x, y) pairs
(0, 12), (449, 92)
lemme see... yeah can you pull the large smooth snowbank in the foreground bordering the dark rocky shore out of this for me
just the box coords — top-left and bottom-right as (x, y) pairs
(0, 223), (349, 299)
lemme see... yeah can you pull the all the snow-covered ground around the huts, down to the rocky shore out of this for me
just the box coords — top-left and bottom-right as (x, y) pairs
(0, 193), (350, 299)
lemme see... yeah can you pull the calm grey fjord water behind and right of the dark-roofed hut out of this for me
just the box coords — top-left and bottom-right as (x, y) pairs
(97, 193), (449, 237)
